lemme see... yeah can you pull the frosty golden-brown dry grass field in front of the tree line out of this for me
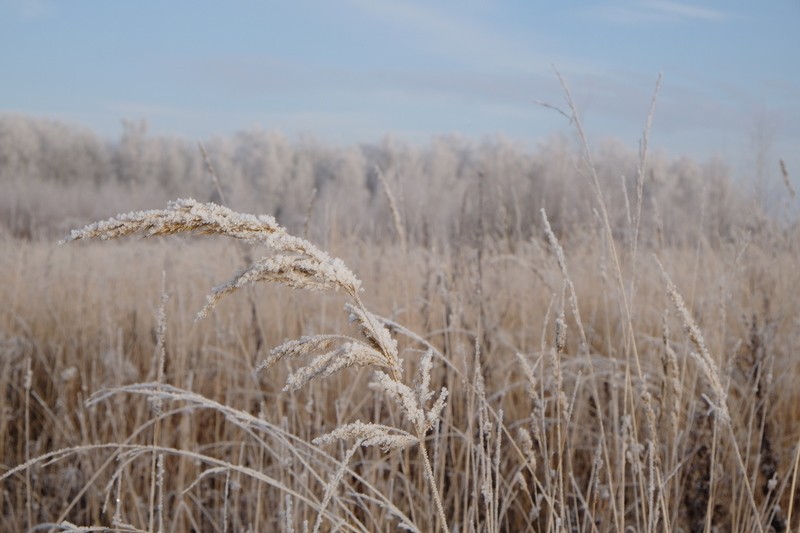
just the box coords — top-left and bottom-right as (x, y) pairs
(0, 102), (800, 532)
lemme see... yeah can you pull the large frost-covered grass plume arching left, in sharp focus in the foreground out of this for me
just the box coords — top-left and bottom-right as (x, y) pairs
(62, 199), (448, 531)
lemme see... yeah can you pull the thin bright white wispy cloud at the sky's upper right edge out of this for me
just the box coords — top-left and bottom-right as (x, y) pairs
(588, 0), (731, 24)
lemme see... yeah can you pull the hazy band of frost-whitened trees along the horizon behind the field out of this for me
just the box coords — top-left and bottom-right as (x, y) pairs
(0, 115), (766, 246)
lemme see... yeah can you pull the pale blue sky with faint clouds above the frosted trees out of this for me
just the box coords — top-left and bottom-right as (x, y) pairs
(0, 0), (800, 177)
